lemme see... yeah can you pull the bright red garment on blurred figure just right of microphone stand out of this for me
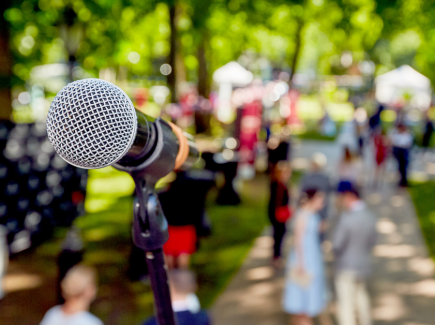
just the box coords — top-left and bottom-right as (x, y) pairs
(163, 225), (196, 257)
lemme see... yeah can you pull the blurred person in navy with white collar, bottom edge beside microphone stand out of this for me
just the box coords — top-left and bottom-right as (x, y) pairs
(143, 270), (211, 325)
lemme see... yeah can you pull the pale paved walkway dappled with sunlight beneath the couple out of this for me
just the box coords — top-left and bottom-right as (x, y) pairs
(212, 141), (435, 325)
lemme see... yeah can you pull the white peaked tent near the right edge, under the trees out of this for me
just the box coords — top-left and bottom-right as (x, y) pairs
(375, 65), (432, 109)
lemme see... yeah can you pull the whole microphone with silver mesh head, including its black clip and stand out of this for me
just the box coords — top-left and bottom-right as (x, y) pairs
(47, 79), (199, 325)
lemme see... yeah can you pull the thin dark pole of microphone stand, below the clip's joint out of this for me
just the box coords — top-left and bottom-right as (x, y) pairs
(145, 248), (176, 325)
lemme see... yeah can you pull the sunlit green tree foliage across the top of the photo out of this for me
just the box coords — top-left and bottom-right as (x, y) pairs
(4, 0), (435, 87)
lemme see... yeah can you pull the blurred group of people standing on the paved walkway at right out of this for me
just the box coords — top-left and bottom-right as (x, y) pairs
(268, 100), (433, 325)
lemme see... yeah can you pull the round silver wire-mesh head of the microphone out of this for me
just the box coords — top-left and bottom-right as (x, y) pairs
(47, 79), (137, 169)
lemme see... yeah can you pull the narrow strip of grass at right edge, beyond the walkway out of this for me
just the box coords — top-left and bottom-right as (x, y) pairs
(409, 181), (435, 260)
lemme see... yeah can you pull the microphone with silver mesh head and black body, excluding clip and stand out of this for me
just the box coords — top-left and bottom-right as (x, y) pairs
(47, 78), (199, 172)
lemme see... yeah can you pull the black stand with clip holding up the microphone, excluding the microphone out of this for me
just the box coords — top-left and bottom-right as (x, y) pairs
(113, 118), (178, 325)
